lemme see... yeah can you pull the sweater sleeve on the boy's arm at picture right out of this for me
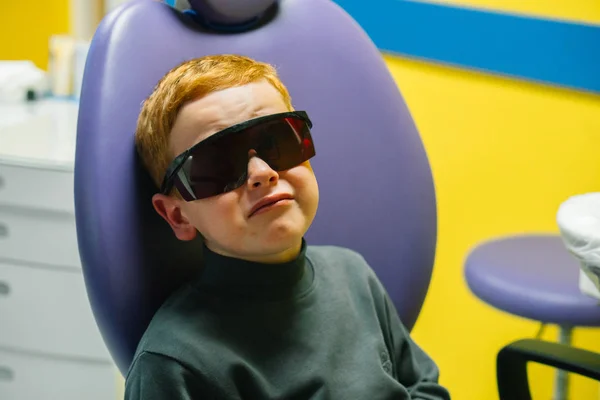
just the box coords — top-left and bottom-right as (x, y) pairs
(383, 294), (450, 400)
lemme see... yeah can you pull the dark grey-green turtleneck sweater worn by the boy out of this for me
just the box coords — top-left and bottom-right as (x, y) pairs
(125, 242), (450, 400)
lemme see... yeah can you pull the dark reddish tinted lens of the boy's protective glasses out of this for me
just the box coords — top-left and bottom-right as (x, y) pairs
(176, 113), (315, 201)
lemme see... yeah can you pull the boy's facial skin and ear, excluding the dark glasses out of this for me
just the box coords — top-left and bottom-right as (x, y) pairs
(152, 81), (319, 263)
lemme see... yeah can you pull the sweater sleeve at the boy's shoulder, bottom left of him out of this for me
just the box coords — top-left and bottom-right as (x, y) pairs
(125, 352), (213, 400)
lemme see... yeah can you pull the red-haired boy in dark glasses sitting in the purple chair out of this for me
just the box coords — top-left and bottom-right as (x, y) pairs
(125, 55), (449, 400)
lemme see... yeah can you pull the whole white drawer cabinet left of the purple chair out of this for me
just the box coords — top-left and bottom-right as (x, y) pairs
(0, 101), (118, 400)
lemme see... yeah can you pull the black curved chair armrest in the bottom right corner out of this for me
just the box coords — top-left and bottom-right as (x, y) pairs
(496, 339), (600, 400)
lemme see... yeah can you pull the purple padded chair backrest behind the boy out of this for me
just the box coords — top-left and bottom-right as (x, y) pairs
(75, 0), (436, 372)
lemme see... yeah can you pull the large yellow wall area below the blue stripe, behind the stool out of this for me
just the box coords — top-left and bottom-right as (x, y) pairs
(386, 56), (600, 400)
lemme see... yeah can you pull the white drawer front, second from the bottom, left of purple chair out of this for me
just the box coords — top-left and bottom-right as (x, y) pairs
(0, 262), (109, 360)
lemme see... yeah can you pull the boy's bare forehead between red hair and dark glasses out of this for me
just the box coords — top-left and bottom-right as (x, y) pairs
(170, 81), (288, 155)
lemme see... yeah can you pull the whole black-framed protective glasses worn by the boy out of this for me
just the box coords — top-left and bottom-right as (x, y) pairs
(160, 111), (315, 201)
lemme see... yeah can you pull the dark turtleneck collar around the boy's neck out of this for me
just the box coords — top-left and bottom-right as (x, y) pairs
(198, 239), (314, 298)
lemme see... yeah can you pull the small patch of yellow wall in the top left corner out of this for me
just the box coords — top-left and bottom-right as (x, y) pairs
(0, 0), (69, 69)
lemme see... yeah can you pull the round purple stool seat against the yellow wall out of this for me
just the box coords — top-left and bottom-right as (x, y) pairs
(465, 235), (600, 327)
